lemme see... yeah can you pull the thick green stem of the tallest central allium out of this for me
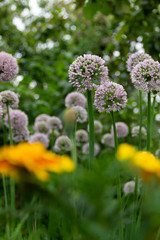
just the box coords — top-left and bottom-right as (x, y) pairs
(87, 90), (95, 169)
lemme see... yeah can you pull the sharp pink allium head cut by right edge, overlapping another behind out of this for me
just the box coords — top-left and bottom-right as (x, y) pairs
(131, 60), (160, 92)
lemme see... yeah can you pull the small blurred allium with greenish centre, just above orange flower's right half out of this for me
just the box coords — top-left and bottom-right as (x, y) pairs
(54, 136), (71, 152)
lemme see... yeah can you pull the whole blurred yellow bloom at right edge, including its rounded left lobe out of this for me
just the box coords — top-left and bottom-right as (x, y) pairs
(117, 143), (160, 180)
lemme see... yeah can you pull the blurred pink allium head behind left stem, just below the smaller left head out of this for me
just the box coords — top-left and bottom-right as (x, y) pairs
(4, 110), (28, 129)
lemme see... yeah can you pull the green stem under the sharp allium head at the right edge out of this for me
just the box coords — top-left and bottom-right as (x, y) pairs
(147, 92), (152, 151)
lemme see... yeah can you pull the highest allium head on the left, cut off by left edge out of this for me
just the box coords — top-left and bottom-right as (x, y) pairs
(0, 52), (18, 82)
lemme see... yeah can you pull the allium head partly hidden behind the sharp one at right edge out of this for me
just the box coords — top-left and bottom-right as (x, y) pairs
(127, 52), (152, 72)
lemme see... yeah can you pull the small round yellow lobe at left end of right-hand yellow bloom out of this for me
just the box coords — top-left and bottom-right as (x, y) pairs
(116, 143), (136, 161)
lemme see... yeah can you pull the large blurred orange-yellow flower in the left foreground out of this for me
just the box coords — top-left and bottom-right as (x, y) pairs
(0, 143), (75, 181)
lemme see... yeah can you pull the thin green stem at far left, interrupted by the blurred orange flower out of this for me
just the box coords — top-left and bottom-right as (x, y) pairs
(7, 105), (15, 214)
